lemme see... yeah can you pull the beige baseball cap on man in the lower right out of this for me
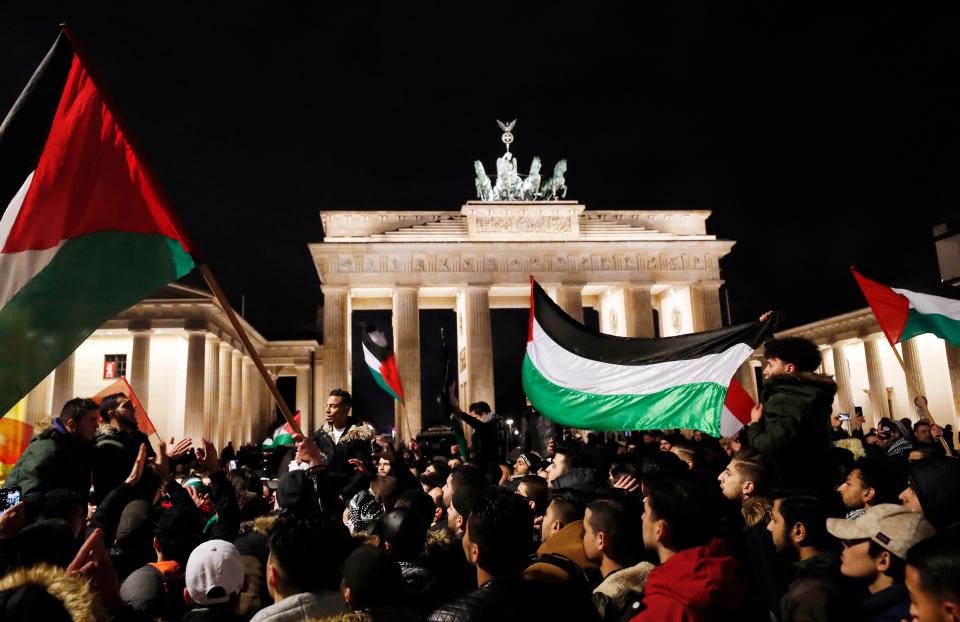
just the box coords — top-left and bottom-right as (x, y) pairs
(827, 503), (936, 559)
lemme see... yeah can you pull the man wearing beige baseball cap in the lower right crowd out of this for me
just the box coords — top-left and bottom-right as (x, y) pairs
(827, 503), (935, 622)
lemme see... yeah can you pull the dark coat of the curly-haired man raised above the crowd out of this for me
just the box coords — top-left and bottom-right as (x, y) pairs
(747, 373), (837, 490)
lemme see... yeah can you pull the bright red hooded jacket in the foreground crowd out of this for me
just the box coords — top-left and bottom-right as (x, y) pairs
(631, 540), (766, 622)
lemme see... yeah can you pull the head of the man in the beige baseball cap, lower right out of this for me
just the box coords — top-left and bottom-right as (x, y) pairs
(827, 503), (934, 585)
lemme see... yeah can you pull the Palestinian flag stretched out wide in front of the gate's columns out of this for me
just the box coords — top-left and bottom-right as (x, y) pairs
(523, 280), (774, 436)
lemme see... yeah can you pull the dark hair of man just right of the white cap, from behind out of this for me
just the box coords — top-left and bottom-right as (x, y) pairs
(269, 515), (349, 593)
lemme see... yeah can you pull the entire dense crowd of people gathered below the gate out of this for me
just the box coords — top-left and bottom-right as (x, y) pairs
(0, 338), (960, 622)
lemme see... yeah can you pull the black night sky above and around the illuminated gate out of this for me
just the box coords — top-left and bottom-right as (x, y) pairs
(0, 1), (960, 432)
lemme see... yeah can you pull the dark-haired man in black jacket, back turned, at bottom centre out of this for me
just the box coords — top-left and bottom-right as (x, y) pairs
(428, 489), (599, 622)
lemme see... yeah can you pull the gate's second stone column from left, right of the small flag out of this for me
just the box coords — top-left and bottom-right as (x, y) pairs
(393, 286), (422, 441)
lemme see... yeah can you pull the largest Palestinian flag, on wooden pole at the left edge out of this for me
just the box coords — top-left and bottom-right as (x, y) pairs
(0, 32), (194, 413)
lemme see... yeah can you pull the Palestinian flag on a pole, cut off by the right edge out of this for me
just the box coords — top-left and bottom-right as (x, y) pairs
(850, 268), (960, 347)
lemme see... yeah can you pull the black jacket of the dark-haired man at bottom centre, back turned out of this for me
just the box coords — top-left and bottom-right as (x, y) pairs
(427, 578), (600, 622)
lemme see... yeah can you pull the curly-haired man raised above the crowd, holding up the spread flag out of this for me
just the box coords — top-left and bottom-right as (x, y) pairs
(747, 338), (837, 492)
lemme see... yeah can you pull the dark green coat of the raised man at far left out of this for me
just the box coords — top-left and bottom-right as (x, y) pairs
(4, 419), (93, 499)
